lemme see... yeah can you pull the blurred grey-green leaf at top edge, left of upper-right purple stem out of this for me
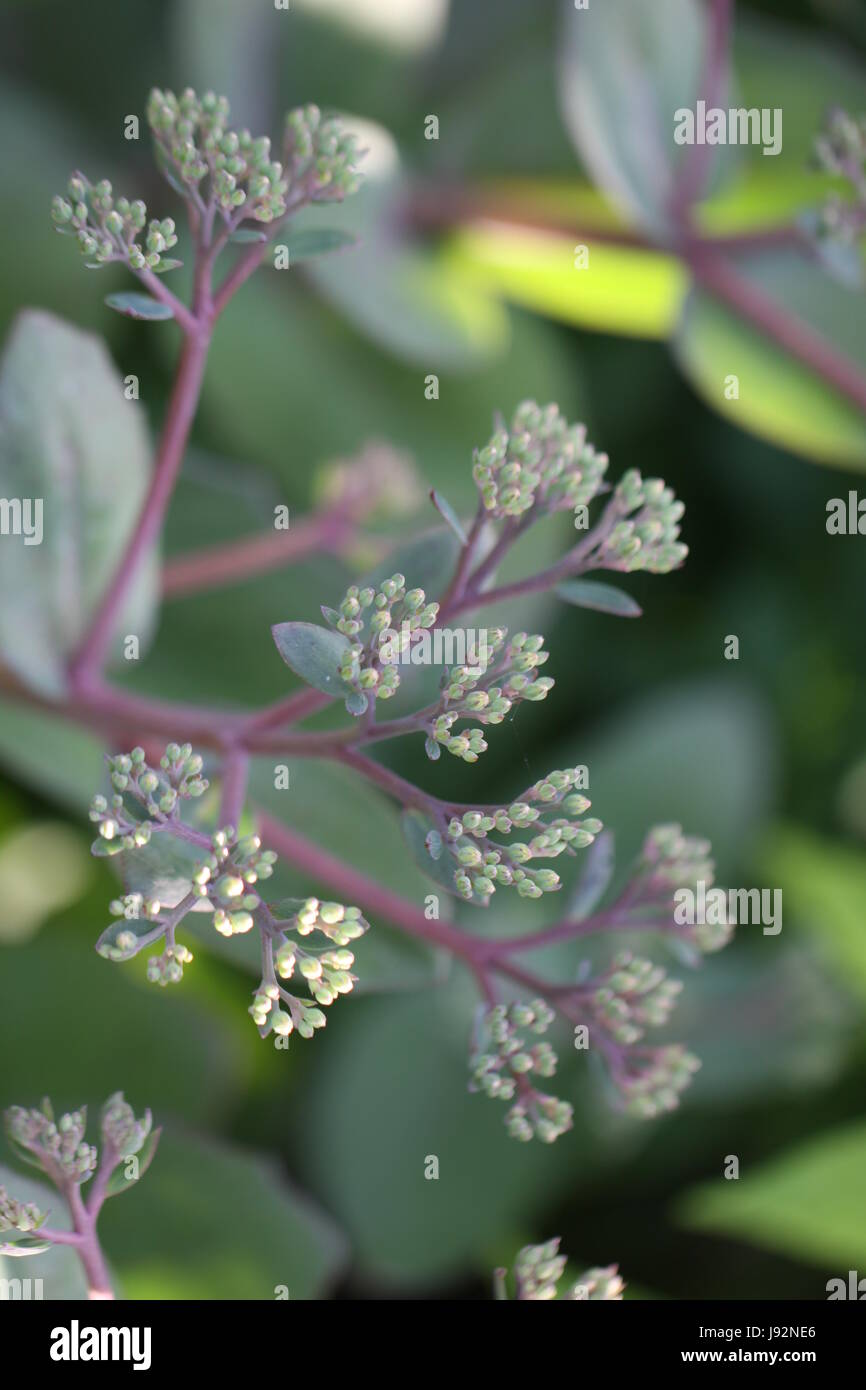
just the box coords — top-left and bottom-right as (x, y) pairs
(559, 0), (735, 238)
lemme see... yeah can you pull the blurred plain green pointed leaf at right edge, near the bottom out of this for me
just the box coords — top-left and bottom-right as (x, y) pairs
(677, 1122), (866, 1273)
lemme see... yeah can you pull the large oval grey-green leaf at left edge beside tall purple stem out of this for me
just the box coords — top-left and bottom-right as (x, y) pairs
(0, 310), (156, 695)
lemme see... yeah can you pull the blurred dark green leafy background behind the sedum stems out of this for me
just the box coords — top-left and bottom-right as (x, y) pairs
(0, 0), (866, 1300)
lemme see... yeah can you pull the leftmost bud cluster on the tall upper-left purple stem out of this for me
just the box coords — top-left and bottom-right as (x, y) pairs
(51, 170), (181, 275)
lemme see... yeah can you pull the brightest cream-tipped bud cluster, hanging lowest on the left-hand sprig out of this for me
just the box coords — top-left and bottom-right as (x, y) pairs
(249, 898), (368, 1037)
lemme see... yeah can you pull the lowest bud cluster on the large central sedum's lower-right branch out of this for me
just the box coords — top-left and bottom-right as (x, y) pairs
(470, 999), (573, 1144)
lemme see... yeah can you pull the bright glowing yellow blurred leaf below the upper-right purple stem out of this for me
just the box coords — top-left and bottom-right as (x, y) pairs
(448, 222), (688, 339)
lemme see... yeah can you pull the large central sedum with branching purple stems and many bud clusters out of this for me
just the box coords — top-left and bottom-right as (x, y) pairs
(0, 90), (727, 1173)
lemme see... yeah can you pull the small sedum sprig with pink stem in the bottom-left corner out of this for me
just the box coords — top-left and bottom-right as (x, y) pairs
(0, 1091), (160, 1298)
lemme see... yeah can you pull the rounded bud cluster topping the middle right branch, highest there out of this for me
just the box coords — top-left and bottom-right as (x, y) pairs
(473, 400), (607, 520)
